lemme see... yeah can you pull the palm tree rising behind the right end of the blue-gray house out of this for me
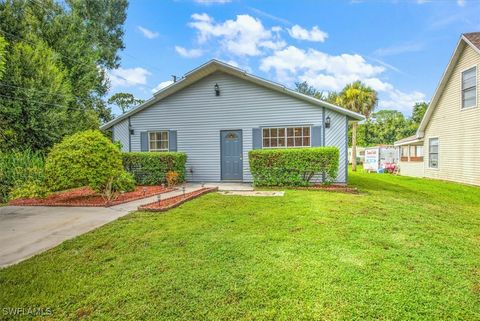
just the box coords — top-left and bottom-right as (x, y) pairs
(336, 80), (377, 171)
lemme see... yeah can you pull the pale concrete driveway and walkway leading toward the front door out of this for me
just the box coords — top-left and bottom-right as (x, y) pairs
(0, 184), (201, 267)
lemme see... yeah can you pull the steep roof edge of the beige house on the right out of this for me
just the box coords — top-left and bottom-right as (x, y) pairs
(417, 32), (480, 138)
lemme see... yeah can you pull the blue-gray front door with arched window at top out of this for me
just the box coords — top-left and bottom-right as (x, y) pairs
(220, 130), (243, 181)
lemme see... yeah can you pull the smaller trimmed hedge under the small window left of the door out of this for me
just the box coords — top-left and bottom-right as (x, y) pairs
(122, 152), (187, 185)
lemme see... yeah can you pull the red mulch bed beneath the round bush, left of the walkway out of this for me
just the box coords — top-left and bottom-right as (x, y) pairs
(9, 186), (173, 207)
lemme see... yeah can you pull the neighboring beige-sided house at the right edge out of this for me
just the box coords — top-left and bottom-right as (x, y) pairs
(395, 32), (480, 185)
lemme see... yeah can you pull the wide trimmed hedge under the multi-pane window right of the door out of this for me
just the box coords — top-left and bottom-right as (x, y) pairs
(248, 147), (339, 186)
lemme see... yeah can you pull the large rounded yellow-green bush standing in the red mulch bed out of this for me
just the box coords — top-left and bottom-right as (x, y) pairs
(45, 130), (124, 192)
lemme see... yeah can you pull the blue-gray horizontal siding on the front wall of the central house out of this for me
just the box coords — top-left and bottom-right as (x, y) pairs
(114, 72), (346, 182)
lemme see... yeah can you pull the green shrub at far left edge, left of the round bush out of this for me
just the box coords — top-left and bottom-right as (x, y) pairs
(0, 150), (45, 203)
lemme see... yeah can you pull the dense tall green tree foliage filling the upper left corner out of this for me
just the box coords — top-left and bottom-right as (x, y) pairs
(0, 0), (127, 150)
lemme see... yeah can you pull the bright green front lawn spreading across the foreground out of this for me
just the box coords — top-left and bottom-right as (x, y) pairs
(0, 173), (480, 320)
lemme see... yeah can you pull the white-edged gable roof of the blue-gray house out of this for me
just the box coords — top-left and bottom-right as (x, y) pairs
(100, 59), (365, 130)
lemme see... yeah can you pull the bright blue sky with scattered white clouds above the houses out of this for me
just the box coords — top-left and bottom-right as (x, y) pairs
(109, 0), (480, 115)
